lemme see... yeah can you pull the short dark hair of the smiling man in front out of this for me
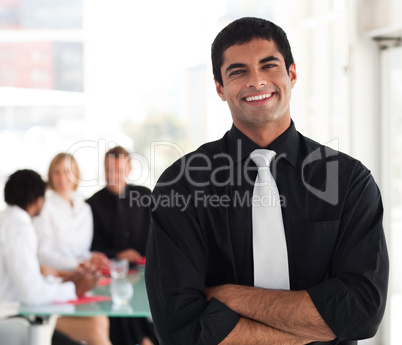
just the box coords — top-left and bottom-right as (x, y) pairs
(211, 17), (294, 86)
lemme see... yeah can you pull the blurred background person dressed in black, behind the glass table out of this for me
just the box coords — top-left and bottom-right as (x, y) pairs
(87, 146), (155, 345)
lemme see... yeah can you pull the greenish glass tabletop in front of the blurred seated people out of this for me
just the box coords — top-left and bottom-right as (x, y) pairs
(18, 268), (151, 317)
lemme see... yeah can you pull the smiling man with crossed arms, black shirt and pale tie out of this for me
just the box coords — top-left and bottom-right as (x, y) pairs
(145, 18), (388, 345)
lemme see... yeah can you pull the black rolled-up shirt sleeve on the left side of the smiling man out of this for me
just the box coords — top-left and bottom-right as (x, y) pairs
(145, 165), (239, 345)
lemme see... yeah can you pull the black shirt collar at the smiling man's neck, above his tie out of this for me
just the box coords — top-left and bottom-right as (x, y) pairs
(226, 120), (299, 167)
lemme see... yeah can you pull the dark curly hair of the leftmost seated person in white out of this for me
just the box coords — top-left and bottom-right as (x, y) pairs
(4, 169), (46, 211)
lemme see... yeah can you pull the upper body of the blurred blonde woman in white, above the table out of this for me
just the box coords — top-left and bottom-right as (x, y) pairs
(33, 153), (109, 271)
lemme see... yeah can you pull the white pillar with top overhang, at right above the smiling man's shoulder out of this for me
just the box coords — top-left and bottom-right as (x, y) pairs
(347, 0), (402, 181)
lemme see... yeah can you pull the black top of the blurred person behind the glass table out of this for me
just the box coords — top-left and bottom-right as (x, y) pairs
(87, 185), (151, 258)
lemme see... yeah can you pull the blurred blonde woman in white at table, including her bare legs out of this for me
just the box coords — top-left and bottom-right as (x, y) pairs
(33, 153), (111, 345)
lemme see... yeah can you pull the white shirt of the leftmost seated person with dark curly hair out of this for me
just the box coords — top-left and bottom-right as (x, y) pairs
(0, 206), (77, 305)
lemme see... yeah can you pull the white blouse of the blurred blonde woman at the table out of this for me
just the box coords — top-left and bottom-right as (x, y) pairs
(33, 190), (93, 270)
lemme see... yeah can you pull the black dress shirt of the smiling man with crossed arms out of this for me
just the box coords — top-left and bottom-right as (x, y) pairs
(145, 122), (388, 345)
